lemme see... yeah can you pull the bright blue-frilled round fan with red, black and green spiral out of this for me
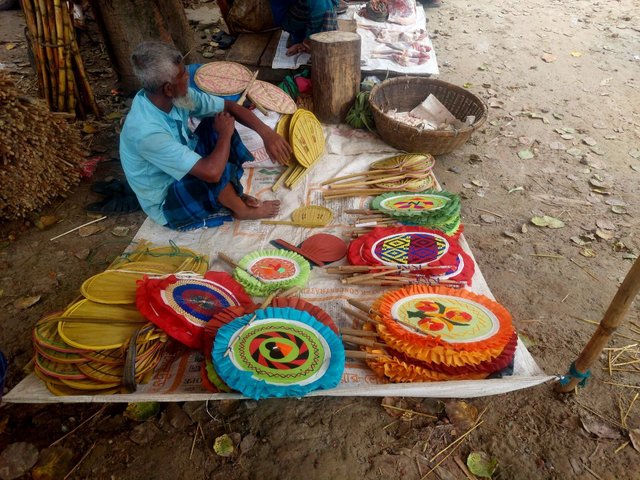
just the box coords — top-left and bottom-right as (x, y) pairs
(212, 308), (345, 399)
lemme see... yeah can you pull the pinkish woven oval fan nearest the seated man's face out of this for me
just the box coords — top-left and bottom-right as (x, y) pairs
(193, 62), (253, 95)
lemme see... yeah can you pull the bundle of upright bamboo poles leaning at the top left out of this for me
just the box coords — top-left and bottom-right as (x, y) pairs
(21, 0), (100, 118)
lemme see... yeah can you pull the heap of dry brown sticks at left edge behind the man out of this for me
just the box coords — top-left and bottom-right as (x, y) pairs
(0, 70), (85, 220)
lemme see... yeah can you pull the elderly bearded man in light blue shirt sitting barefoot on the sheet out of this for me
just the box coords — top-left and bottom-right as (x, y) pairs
(120, 42), (291, 230)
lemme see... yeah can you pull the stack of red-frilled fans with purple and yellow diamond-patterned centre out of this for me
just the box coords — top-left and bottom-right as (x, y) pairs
(347, 226), (475, 286)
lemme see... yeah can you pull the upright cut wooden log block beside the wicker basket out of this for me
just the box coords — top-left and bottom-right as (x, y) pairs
(310, 31), (361, 123)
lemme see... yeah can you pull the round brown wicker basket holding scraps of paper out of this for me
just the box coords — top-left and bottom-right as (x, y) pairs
(369, 77), (487, 155)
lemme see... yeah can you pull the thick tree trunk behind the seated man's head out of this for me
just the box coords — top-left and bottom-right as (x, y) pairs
(91, 0), (195, 92)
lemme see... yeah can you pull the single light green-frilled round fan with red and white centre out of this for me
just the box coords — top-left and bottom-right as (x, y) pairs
(233, 249), (311, 296)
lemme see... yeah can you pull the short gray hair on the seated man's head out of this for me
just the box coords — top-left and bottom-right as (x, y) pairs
(131, 42), (183, 93)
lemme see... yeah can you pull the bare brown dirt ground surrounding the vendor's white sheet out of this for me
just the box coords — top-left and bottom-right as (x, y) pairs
(0, 0), (640, 480)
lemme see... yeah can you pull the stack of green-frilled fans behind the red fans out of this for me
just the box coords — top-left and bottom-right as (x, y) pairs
(371, 190), (460, 235)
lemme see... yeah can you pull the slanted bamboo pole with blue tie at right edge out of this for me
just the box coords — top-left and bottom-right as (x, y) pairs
(556, 258), (640, 393)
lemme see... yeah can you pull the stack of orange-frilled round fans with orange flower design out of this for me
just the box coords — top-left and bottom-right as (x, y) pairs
(365, 286), (517, 382)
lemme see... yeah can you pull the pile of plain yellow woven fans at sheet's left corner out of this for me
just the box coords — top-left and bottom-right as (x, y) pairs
(33, 244), (208, 395)
